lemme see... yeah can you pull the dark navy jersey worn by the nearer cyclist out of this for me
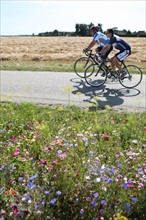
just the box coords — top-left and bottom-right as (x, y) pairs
(109, 34), (131, 51)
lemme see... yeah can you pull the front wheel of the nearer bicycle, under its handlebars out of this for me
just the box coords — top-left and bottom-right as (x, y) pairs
(85, 64), (107, 87)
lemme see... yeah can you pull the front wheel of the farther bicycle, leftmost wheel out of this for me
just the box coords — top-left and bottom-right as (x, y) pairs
(74, 57), (93, 78)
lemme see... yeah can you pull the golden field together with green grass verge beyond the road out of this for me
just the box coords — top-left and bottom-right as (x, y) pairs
(0, 36), (146, 72)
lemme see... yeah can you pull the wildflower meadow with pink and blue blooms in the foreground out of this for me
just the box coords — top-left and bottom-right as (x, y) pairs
(0, 103), (146, 220)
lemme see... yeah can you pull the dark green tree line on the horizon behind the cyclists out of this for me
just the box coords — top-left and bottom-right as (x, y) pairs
(37, 23), (146, 37)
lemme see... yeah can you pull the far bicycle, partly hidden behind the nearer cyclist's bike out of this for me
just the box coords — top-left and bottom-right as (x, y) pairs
(74, 50), (99, 78)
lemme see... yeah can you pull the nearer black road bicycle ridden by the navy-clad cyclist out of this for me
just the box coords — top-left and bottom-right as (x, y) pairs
(84, 52), (143, 89)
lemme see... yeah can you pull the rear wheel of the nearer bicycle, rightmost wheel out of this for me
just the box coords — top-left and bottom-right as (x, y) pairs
(119, 65), (142, 89)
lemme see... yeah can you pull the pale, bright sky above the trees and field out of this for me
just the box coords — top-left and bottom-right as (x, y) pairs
(0, 0), (146, 35)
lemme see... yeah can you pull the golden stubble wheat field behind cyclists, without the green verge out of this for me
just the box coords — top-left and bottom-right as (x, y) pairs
(0, 36), (146, 66)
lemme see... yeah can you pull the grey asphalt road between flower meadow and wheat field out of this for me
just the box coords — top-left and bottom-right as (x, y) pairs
(0, 71), (146, 111)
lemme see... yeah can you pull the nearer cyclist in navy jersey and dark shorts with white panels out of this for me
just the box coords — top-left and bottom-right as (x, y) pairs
(100, 29), (131, 79)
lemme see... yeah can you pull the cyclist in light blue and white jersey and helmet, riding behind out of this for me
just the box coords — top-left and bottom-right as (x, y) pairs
(84, 25), (113, 58)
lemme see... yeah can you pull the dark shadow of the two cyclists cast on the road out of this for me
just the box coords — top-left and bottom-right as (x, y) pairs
(70, 78), (140, 109)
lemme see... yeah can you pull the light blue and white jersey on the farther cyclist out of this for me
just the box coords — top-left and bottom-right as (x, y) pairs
(93, 31), (110, 47)
